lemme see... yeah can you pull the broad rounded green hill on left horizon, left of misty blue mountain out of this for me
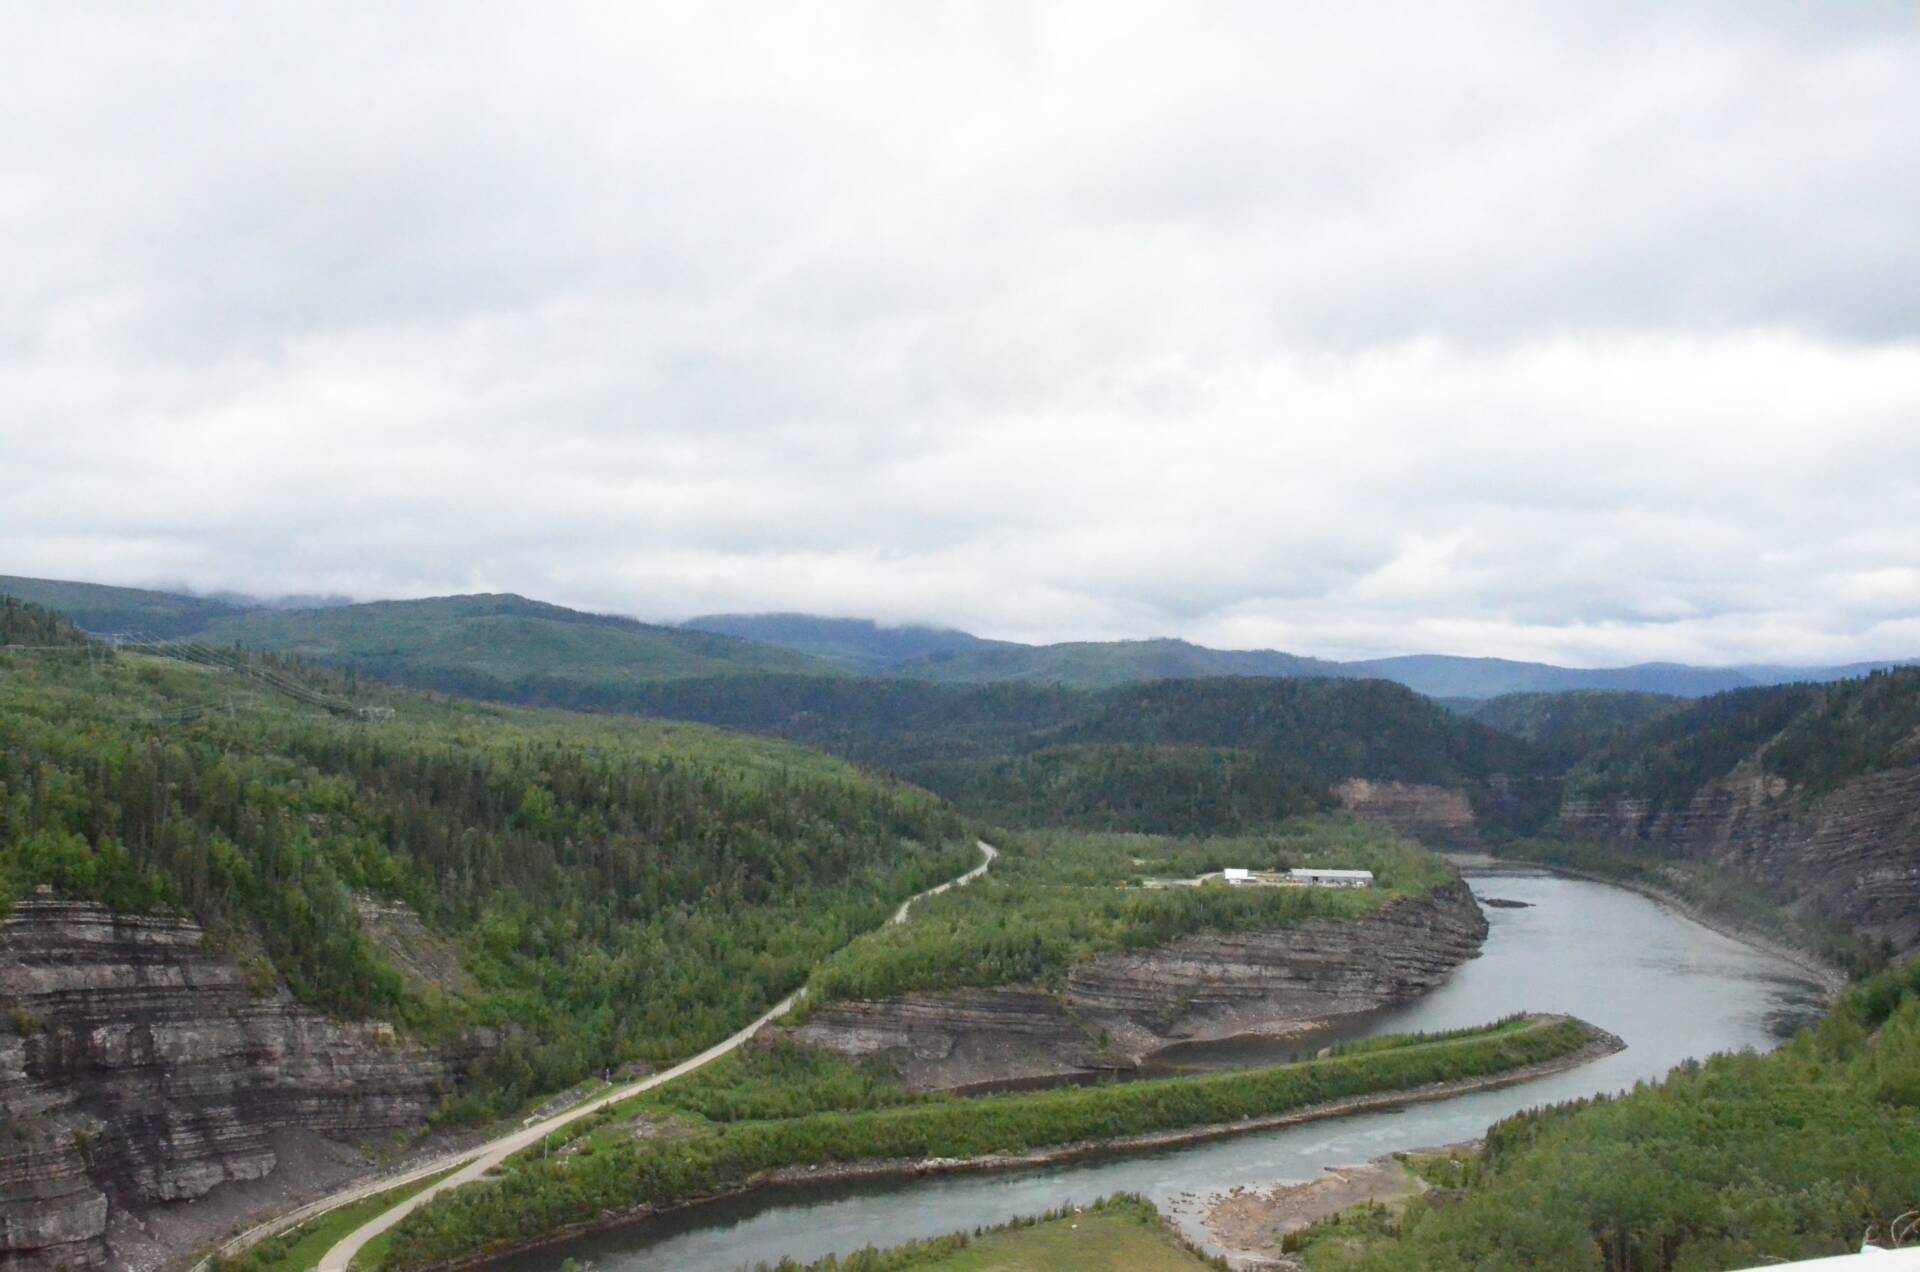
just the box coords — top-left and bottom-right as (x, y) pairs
(200, 596), (839, 699)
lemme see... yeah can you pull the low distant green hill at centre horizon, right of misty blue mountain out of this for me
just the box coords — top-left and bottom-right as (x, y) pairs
(893, 640), (1346, 690)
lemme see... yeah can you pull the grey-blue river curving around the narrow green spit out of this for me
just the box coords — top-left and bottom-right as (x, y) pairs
(492, 868), (1820, 1272)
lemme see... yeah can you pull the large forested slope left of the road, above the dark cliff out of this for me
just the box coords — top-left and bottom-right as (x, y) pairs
(0, 607), (977, 1113)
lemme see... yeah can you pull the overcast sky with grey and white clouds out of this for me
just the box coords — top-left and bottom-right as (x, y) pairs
(0, 0), (1920, 665)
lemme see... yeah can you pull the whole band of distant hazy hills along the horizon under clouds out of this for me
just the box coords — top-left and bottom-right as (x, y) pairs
(0, 576), (1910, 699)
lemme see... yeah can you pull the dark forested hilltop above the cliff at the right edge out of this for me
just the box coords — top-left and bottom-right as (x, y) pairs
(1569, 667), (1920, 807)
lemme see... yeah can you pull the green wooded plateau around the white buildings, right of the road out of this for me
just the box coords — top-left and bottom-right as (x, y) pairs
(801, 817), (1455, 1015)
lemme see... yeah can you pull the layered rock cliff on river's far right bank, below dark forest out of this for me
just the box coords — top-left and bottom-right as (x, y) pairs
(1561, 765), (1920, 953)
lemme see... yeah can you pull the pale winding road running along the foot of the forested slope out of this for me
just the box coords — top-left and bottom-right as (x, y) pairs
(194, 840), (1000, 1272)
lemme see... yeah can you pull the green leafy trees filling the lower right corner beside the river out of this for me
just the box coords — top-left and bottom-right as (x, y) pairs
(1302, 961), (1920, 1272)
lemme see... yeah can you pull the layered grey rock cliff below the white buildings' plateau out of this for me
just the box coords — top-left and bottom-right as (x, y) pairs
(791, 882), (1486, 1089)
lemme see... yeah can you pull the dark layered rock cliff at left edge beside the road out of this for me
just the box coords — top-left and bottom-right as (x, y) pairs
(0, 899), (447, 1272)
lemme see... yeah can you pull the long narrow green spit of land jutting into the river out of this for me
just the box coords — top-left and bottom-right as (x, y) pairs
(382, 1018), (1601, 1270)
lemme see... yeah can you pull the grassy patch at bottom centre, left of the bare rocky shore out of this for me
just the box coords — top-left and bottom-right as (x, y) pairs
(755, 1193), (1229, 1272)
